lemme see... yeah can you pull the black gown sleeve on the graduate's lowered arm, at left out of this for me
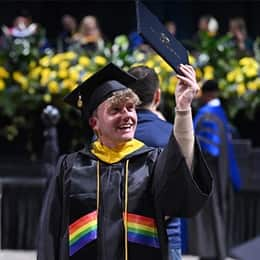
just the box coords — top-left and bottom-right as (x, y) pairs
(37, 156), (70, 260)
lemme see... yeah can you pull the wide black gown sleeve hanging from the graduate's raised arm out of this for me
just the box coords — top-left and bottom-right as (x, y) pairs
(153, 135), (213, 217)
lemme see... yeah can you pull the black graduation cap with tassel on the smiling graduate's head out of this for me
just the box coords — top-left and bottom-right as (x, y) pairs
(64, 63), (136, 145)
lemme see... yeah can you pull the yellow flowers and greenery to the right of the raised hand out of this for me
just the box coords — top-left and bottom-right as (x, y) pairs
(188, 34), (260, 120)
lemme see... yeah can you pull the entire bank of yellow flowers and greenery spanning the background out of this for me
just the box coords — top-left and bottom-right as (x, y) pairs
(0, 25), (260, 157)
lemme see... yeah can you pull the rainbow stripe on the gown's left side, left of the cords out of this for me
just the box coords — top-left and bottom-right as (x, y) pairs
(69, 210), (97, 256)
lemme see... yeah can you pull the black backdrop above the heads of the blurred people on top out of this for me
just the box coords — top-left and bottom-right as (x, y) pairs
(0, 0), (260, 46)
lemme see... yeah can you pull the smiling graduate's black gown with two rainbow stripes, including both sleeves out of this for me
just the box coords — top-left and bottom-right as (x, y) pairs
(38, 136), (212, 260)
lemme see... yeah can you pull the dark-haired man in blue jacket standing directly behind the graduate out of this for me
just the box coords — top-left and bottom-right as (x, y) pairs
(129, 66), (181, 260)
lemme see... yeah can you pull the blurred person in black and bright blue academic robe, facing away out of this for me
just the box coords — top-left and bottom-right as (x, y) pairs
(187, 80), (241, 260)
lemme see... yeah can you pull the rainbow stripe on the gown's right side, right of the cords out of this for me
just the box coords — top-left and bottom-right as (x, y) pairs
(127, 213), (160, 248)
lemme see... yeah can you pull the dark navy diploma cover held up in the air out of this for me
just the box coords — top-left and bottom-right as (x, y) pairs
(136, 0), (189, 75)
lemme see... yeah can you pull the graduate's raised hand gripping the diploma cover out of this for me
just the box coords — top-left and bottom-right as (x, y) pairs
(175, 64), (199, 110)
